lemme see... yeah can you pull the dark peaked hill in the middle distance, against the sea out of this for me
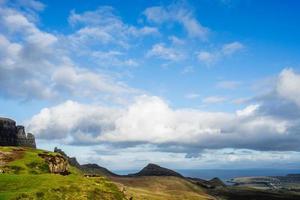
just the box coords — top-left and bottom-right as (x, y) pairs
(128, 163), (183, 178)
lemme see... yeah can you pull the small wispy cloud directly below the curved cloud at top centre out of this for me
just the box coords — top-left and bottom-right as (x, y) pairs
(147, 43), (184, 61)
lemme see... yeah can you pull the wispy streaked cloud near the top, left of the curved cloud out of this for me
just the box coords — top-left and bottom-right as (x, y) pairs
(69, 6), (159, 48)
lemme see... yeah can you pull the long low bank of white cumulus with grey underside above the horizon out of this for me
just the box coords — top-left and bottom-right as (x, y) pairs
(27, 75), (300, 153)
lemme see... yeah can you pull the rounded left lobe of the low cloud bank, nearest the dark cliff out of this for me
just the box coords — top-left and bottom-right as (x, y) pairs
(28, 101), (118, 143)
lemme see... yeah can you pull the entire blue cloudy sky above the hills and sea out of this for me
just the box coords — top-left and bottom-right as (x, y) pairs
(0, 0), (300, 171)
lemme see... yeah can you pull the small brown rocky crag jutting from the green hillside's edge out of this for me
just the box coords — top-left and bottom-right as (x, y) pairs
(39, 153), (69, 175)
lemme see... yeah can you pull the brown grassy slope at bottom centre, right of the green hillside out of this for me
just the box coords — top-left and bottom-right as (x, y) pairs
(112, 176), (214, 200)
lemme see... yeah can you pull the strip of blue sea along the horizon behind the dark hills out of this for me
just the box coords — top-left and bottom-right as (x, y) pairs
(115, 168), (300, 183)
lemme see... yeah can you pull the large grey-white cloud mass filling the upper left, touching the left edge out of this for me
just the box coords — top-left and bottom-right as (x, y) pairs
(0, 6), (137, 102)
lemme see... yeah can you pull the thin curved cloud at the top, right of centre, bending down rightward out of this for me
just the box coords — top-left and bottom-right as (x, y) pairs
(144, 4), (209, 40)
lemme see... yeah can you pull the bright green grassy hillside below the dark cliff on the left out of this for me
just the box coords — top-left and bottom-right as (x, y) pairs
(0, 147), (124, 200)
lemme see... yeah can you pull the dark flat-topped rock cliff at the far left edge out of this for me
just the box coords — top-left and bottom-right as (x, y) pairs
(0, 117), (36, 148)
